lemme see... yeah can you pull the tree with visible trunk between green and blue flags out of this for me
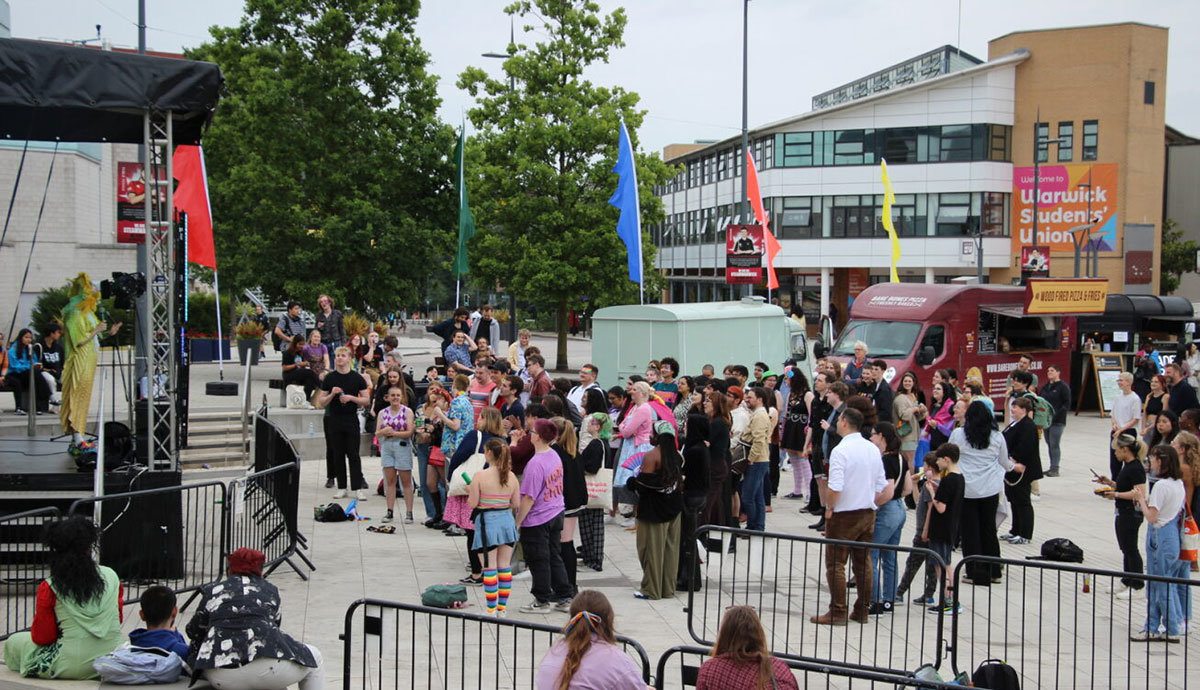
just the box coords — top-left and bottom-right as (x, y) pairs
(458, 0), (673, 370)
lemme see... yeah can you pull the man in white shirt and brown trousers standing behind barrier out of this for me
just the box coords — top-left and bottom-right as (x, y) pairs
(810, 408), (895, 625)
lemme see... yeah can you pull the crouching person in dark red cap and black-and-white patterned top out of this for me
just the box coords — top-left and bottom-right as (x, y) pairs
(187, 548), (325, 690)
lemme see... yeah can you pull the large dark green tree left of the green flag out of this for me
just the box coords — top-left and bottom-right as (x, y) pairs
(188, 0), (454, 313)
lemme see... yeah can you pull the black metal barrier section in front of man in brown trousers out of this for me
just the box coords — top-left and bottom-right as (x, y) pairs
(688, 526), (946, 673)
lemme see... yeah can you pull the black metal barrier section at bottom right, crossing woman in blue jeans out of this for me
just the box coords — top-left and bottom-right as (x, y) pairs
(950, 556), (1200, 689)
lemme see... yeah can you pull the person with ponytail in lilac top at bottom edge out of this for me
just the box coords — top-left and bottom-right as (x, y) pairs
(536, 589), (647, 690)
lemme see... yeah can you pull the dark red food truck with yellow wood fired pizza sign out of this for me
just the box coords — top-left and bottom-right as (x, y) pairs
(824, 280), (1108, 409)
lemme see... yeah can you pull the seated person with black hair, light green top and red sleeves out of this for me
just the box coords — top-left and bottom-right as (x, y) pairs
(4, 516), (125, 680)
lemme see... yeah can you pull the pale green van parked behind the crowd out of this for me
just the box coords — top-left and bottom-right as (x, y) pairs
(592, 298), (812, 388)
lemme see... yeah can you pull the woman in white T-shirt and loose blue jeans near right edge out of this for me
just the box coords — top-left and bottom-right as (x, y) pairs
(1129, 445), (1190, 642)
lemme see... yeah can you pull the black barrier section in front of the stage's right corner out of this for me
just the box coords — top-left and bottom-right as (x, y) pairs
(68, 481), (228, 606)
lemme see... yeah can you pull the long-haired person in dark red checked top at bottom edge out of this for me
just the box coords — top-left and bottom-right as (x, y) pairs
(696, 606), (798, 690)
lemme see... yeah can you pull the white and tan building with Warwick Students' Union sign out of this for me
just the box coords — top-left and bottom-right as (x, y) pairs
(650, 24), (1166, 322)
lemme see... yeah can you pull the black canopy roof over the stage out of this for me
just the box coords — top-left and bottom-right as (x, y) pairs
(0, 38), (222, 144)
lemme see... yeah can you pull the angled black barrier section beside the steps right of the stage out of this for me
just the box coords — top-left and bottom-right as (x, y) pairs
(228, 462), (308, 580)
